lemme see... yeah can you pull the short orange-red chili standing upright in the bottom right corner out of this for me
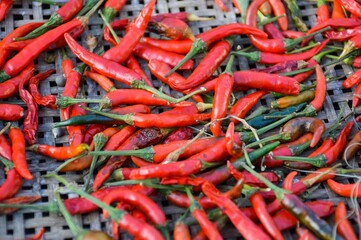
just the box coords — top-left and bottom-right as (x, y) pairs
(335, 201), (358, 240)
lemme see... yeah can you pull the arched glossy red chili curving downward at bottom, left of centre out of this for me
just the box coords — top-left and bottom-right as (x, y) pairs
(102, 189), (166, 226)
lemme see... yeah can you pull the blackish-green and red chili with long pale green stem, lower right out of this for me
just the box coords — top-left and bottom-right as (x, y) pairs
(242, 163), (340, 239)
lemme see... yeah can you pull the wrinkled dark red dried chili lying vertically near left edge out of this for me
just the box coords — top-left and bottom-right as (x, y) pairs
(19, 74), (39, 144)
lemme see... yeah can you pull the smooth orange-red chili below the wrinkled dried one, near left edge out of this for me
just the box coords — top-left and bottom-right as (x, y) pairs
(9, 127), (33, 180)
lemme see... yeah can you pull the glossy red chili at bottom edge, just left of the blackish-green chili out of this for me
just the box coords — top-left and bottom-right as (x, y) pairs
(247, 193), (283, 239)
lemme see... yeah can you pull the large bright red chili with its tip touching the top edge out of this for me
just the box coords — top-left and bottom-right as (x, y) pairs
(103, 0), (156, 63)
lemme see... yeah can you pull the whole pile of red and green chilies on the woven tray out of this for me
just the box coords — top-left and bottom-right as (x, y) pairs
(0, 0), (361, 239)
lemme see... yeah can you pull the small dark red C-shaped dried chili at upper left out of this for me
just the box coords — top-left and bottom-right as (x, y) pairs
(29, 69), (57, 109)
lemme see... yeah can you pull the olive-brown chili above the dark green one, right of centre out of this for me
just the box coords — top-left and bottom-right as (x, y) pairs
(271, 90), (315, 108)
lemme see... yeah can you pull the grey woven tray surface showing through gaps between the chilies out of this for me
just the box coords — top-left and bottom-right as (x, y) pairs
(0, 0), (361, 240)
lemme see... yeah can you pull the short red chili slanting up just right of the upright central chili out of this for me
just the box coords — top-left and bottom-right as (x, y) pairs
(229, 90), (268, 123)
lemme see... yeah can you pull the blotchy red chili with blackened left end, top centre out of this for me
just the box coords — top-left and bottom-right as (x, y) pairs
(147, 18), (194, 40)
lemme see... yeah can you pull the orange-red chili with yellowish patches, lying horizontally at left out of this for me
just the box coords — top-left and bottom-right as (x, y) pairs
(29, 143), (89, 160)
